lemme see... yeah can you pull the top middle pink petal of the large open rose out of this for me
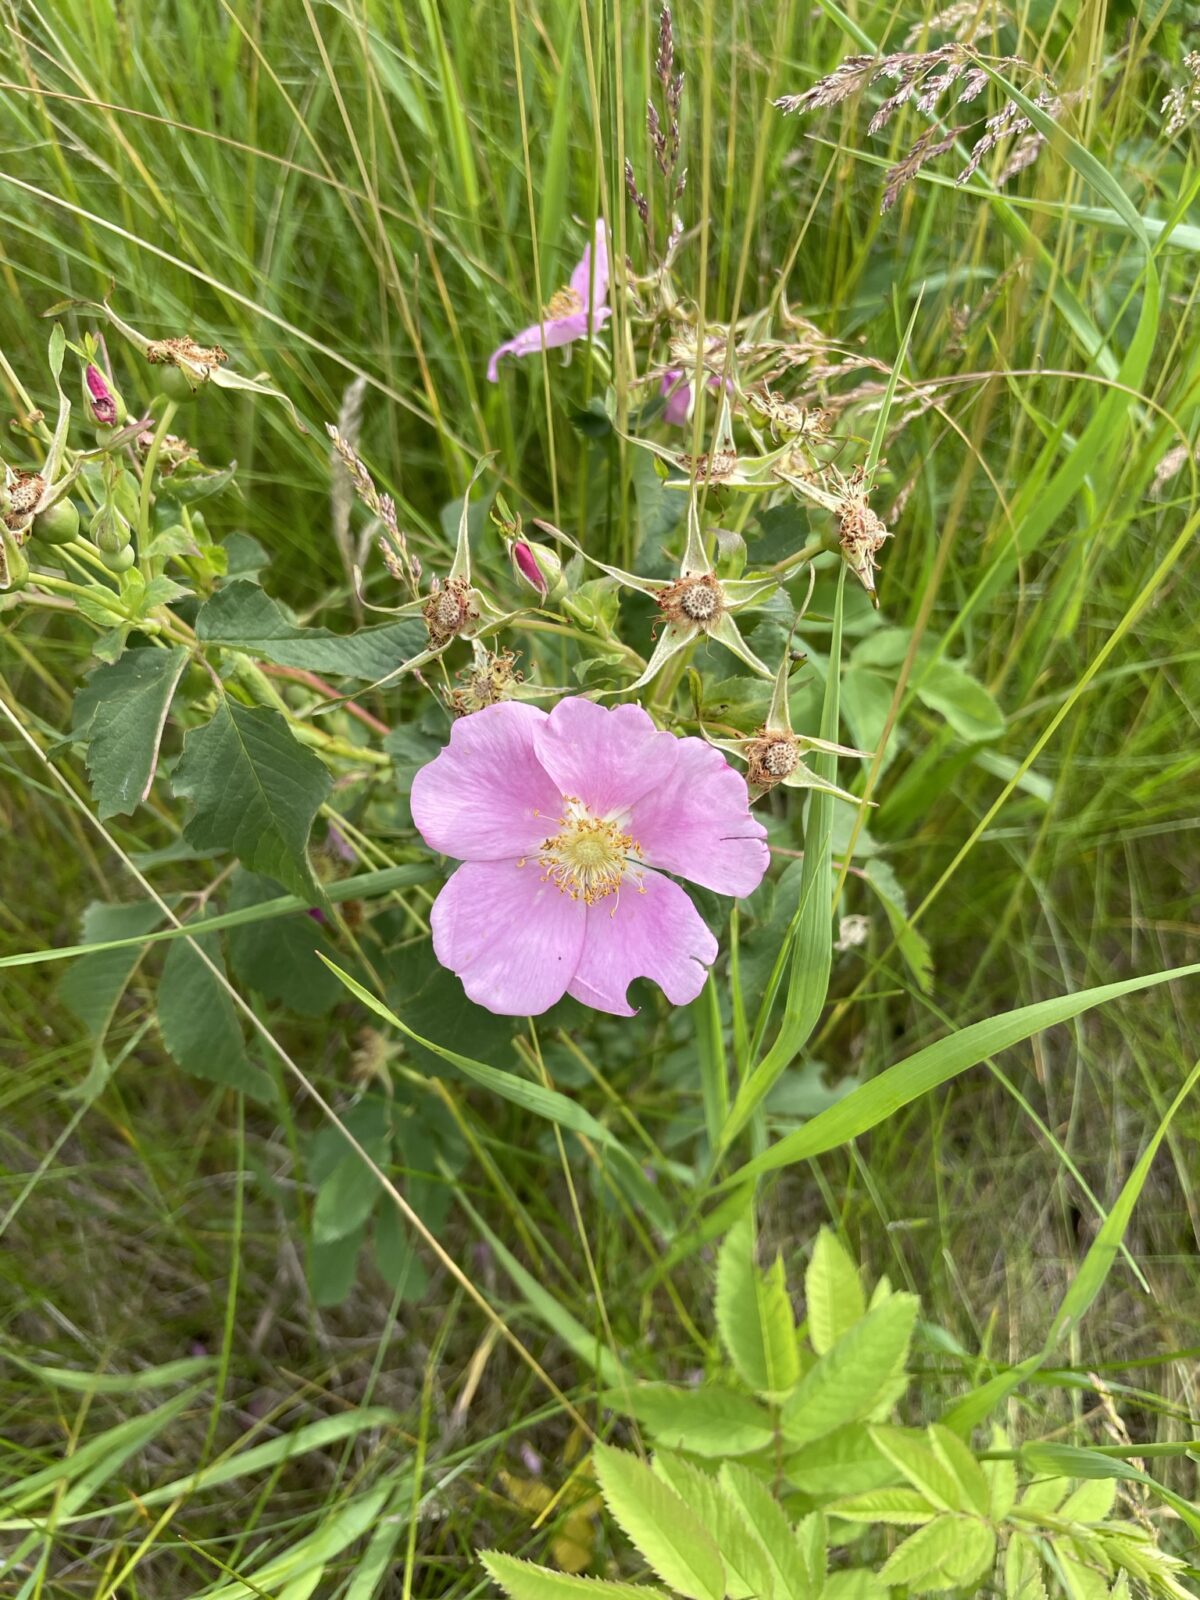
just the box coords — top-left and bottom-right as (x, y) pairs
(533, 696), (680, 816)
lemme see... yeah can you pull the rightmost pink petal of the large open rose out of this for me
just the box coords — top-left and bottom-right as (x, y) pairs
(630, 732), (771, 894)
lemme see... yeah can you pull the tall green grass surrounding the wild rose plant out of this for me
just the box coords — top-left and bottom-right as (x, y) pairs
(0, 0), (1200, 1600)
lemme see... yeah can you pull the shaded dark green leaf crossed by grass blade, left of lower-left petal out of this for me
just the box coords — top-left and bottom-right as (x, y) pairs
(227, 867), (342, 1016)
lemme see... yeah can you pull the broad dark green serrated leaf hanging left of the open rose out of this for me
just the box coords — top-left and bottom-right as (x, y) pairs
(174, 698), (333, 906)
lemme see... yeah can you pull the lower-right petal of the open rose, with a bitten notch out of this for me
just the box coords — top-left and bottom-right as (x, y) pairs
(568, 872), (717, 1016)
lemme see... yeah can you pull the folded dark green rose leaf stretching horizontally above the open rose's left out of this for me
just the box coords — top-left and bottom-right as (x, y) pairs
(195, 578), (427, 683)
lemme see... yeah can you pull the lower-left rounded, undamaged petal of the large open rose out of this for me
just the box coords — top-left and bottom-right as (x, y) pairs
(429, 861), (587, 1016)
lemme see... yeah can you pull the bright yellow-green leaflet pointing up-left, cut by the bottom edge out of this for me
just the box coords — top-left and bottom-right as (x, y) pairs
(592, 1443), (725, 1600)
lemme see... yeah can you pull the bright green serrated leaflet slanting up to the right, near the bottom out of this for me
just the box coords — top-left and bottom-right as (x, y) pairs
(782, 1294), (917, 1445)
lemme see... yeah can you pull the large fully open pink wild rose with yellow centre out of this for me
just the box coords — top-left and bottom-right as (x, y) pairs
(411, 698), (768, 1016)
